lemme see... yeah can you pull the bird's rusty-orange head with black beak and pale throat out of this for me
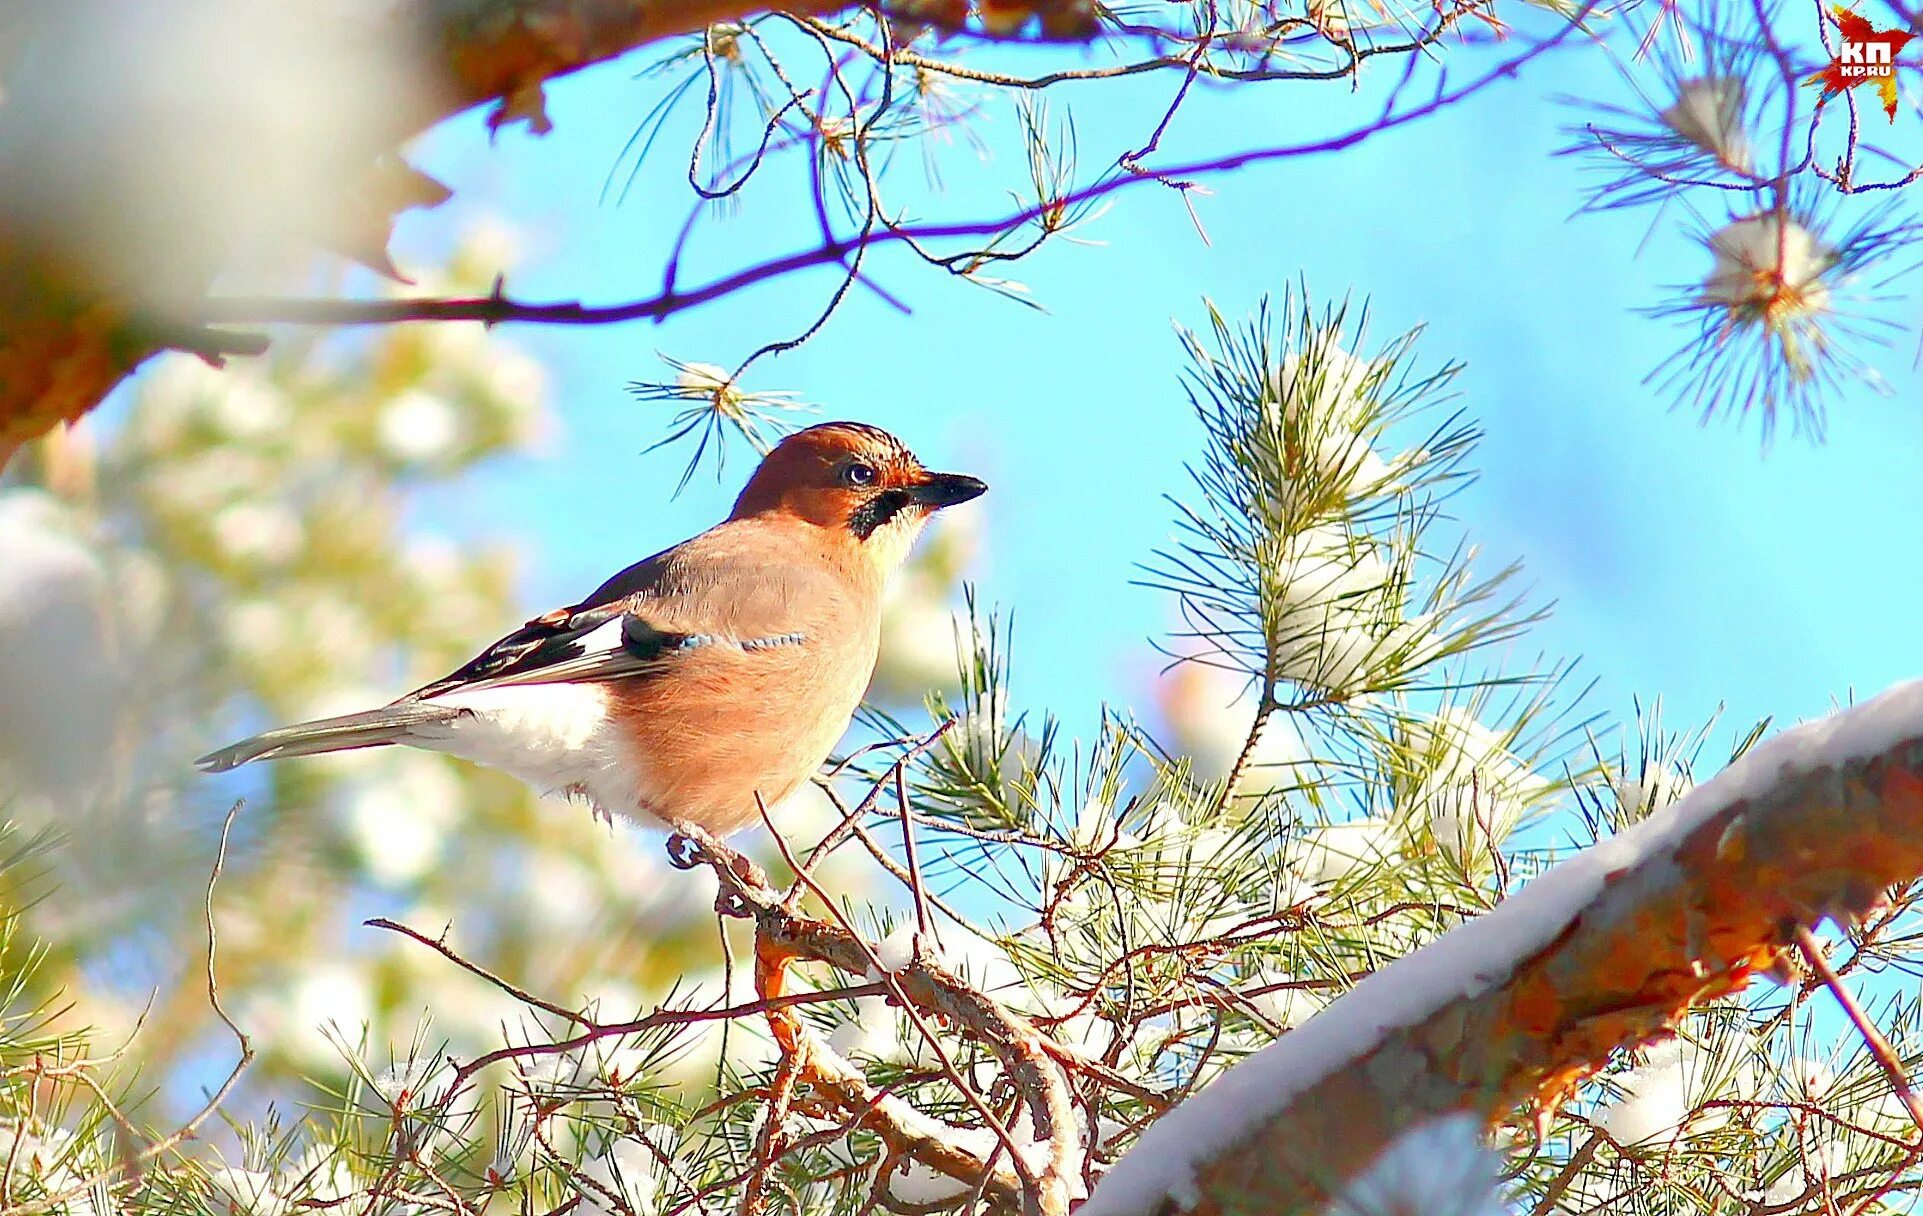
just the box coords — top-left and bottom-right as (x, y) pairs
(735, 421), (988, 573)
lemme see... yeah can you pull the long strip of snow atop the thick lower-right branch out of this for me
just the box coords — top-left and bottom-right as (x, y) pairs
(1077, 679), (1923, 1216)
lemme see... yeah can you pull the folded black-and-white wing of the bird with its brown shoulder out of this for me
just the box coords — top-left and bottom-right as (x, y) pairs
(402, 525), (842, 700)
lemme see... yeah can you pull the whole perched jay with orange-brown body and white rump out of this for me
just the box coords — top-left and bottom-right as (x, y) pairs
(198, 421), (988, 835)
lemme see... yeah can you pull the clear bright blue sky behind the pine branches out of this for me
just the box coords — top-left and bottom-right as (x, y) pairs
(386, 30), (1923, 754)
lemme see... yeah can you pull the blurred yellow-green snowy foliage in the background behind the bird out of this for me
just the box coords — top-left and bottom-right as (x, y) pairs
(0, 227), (971, 1124)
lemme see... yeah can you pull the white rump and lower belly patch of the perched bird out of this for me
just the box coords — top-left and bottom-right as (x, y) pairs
(410, 683), (644, 818)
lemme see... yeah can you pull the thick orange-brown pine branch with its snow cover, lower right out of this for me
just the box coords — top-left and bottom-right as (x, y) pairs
(1081, 681), (1923, 1216)
